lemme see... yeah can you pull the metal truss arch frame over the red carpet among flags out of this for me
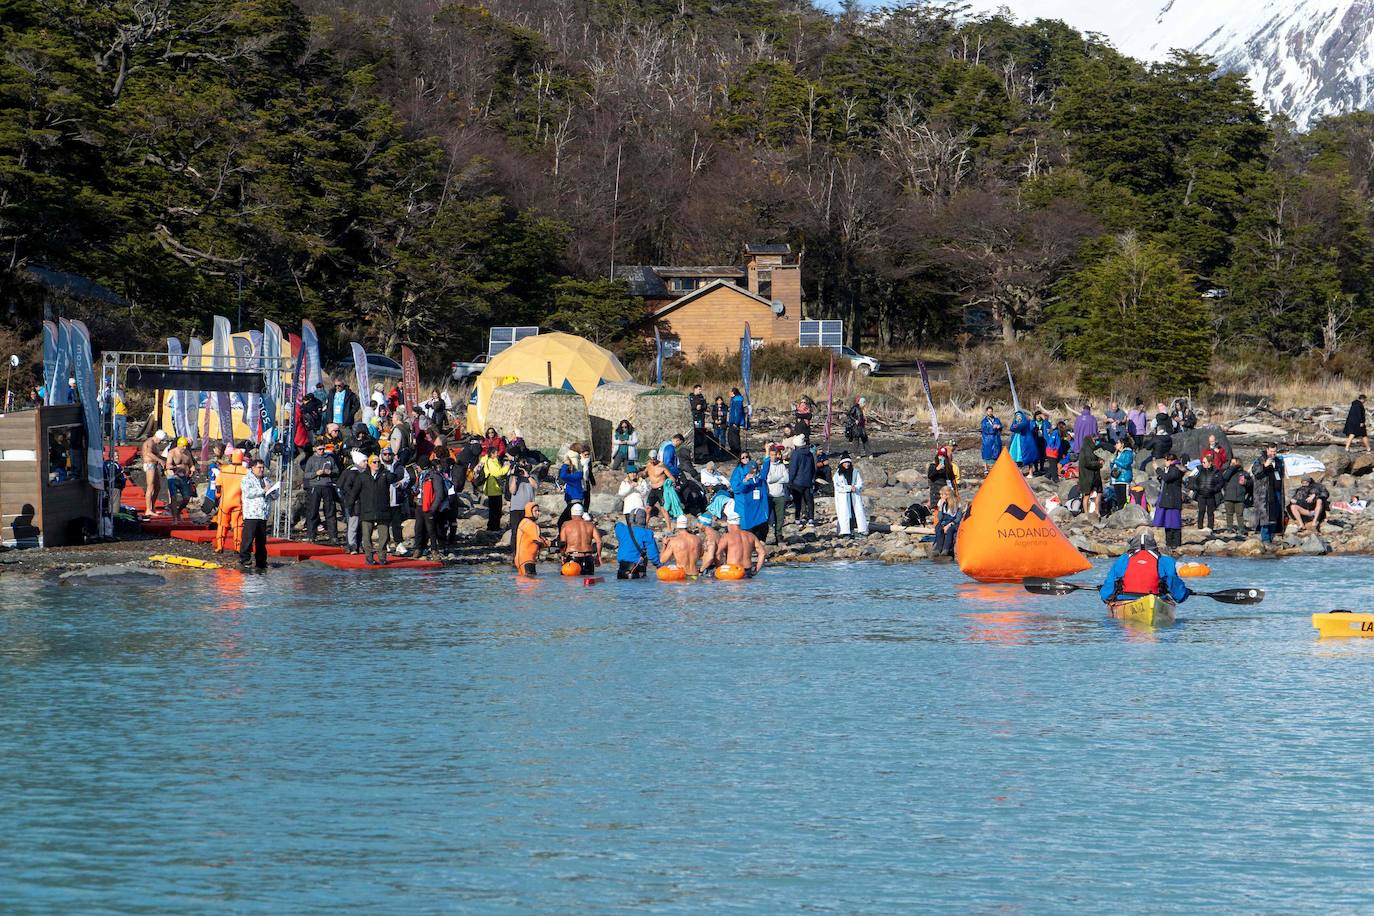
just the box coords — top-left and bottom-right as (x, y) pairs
(100, 350), (295, 540)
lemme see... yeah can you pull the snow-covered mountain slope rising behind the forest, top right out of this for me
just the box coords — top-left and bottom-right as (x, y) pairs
(970, 0), (1374, 126)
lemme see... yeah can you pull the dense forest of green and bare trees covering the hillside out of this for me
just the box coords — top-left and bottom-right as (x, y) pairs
(0, 0), (1374, 390)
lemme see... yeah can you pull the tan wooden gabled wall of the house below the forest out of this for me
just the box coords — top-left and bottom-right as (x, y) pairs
(657, 283), (797, 360)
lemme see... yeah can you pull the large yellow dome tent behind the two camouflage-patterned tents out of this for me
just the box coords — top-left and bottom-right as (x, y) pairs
(467, 331), (632, 435)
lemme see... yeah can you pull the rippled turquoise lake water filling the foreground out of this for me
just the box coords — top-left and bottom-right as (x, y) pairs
(0, 558), (1374, 913)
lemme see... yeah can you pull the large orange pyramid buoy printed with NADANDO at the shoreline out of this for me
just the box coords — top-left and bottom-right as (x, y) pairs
(955, 449), (1092, 582)
